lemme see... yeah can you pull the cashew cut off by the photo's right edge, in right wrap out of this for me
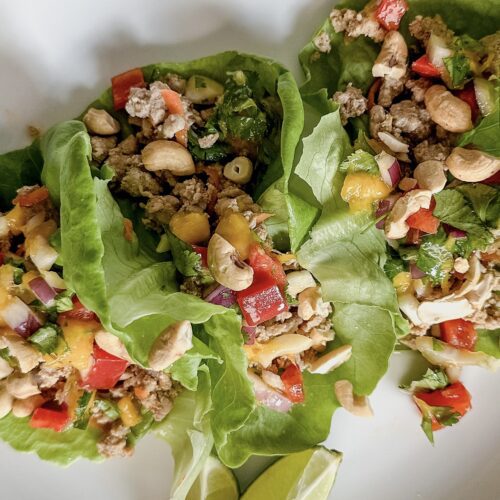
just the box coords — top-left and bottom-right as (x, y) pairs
(445, 148), (500, 182)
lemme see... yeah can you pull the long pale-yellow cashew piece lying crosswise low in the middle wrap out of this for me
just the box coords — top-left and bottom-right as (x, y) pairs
(243, 333), (313, 368)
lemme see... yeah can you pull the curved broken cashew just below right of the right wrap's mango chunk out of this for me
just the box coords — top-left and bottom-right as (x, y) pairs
(385, 189), (432, 240)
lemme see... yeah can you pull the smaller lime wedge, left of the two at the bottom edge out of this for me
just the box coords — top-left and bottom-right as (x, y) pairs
(186, 457), (240, 500)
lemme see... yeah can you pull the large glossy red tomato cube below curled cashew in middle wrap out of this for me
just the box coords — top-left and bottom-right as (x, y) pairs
(236, 271), (288, 326)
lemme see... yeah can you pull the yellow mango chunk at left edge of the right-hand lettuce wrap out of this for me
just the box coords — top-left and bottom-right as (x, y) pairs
(340, 172), (392, 212)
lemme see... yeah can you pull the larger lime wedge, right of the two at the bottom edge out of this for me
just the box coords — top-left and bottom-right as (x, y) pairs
(241, 446), (342, 500)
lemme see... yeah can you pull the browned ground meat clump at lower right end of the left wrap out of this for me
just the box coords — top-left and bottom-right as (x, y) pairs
(123, 365), (181, 421)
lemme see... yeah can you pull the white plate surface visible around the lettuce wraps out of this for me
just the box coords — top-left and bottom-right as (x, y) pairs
(0, 0), (500, 500)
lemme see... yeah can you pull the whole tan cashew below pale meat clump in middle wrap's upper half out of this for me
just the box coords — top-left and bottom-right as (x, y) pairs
(142, 139), (195, 175)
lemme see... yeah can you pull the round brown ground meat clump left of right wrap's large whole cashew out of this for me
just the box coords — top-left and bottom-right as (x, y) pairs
(390, 100), (432, 141)
